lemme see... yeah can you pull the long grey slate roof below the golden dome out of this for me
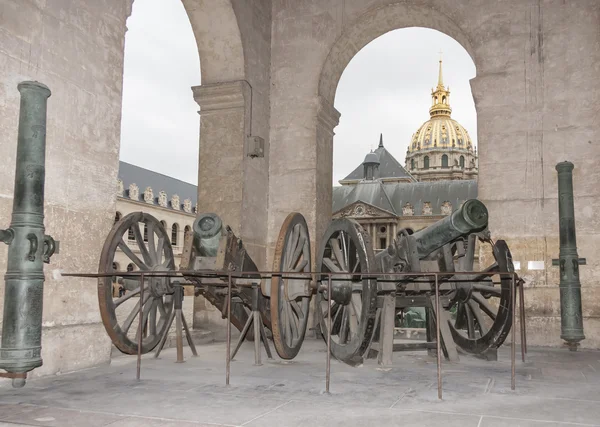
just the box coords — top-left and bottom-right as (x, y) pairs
(333, 180), (477, 216)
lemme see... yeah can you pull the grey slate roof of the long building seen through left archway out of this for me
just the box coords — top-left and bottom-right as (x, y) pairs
(119, 161), (198, 206)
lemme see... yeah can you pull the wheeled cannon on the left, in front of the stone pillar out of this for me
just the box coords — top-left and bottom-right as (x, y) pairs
(98, 212), (311, 359)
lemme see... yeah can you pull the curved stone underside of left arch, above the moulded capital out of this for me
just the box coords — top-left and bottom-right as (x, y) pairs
(182, 0), (245, 84)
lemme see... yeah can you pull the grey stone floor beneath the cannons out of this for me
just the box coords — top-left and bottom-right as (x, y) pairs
(0, 338), (600, 427)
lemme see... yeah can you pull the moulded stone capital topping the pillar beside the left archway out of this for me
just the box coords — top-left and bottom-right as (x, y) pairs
(192, 80), (251, 114)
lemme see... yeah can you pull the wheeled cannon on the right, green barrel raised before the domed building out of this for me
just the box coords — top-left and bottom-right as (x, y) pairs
(315, 200), (514, 365)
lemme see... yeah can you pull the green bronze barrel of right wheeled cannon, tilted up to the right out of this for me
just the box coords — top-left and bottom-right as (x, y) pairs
(411, 199), (488, 259)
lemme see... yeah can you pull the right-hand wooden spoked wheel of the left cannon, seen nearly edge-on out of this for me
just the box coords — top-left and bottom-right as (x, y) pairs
(271, 212), (311, 359)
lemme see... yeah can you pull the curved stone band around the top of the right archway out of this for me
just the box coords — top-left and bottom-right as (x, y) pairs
(318, 2), (477, 105)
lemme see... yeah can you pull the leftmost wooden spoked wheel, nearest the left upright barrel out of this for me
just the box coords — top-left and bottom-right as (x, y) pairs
(98, 212), (175, 354)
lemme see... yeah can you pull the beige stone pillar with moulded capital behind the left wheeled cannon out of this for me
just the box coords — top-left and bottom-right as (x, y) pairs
(192, 80), (267, 328)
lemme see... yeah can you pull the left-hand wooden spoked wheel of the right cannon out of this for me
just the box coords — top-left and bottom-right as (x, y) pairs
(316, 218), (377, 365)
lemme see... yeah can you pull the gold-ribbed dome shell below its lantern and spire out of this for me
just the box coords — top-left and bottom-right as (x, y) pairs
(408, 116), (473, 153)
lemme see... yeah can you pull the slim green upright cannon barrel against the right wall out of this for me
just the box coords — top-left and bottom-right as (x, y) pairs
(552, 162), (585, 350)
